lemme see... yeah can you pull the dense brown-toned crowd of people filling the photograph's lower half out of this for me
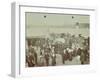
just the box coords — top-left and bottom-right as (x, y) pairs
(26, 33), (90, 67)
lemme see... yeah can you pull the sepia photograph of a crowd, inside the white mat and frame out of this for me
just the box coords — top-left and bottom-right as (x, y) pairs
(25, 12), (90, 67)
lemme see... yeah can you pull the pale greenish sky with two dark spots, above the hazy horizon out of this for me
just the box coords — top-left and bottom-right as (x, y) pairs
(25, 12), (89, 27)
